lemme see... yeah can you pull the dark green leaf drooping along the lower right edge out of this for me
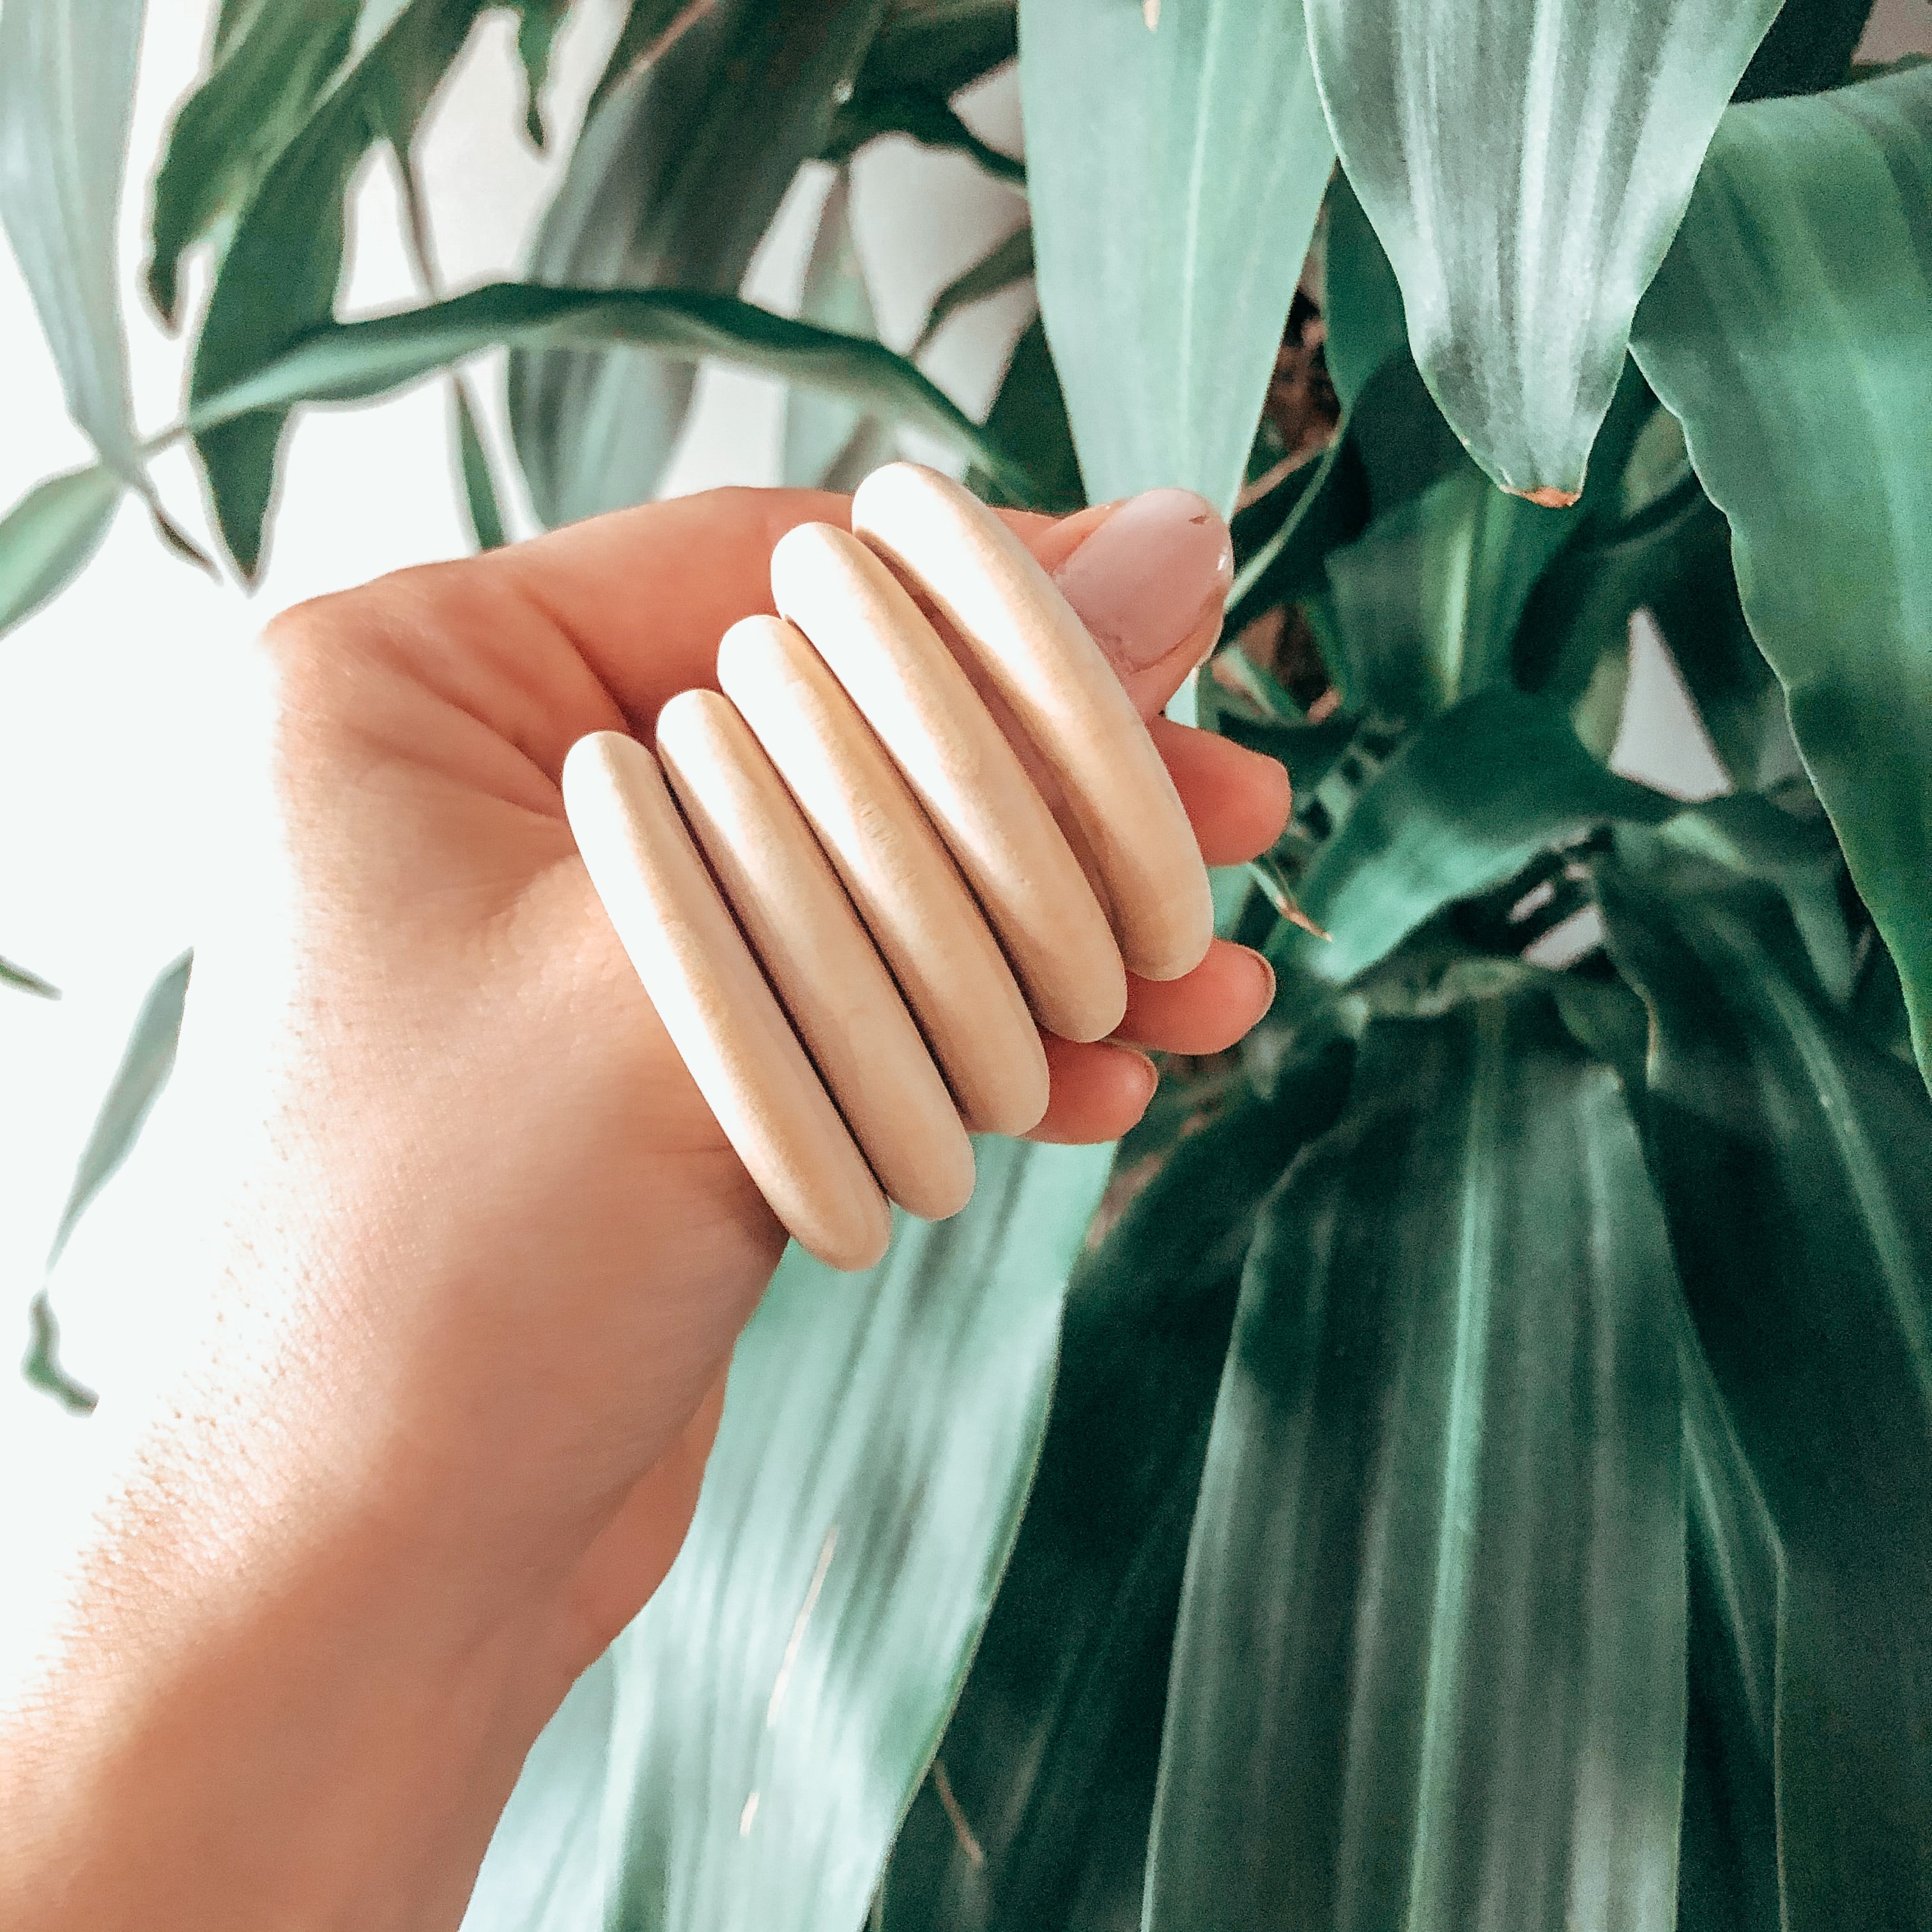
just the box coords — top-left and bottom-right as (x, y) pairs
(1598, 850), (1932, 1932)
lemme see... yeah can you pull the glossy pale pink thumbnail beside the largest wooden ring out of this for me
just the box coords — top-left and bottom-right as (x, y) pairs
(1055, 489), (1234, 670)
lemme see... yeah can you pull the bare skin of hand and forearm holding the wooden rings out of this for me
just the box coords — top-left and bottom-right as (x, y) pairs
(0, 479), (1289, 1932)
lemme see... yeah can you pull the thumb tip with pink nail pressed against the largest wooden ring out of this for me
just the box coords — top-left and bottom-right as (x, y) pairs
(1034, 489), (1234, 717)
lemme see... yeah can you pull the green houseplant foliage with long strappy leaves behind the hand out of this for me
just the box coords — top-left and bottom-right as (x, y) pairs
(0, 0), (1932, 1932)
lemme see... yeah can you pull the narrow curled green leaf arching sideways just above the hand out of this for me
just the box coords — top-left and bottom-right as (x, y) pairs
(189, 282), (1032, 494)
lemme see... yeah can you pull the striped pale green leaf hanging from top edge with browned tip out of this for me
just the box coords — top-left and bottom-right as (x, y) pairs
(1306, 0), (1777, 504)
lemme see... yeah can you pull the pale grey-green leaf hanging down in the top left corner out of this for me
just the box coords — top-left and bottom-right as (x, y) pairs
(0, 0), (147, 491)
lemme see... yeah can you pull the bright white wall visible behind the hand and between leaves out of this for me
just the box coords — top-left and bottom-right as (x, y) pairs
(0, 0), (1932, 1667)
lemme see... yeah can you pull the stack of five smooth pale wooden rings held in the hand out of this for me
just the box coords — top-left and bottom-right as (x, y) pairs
(564, 464), (1213, 1269)
